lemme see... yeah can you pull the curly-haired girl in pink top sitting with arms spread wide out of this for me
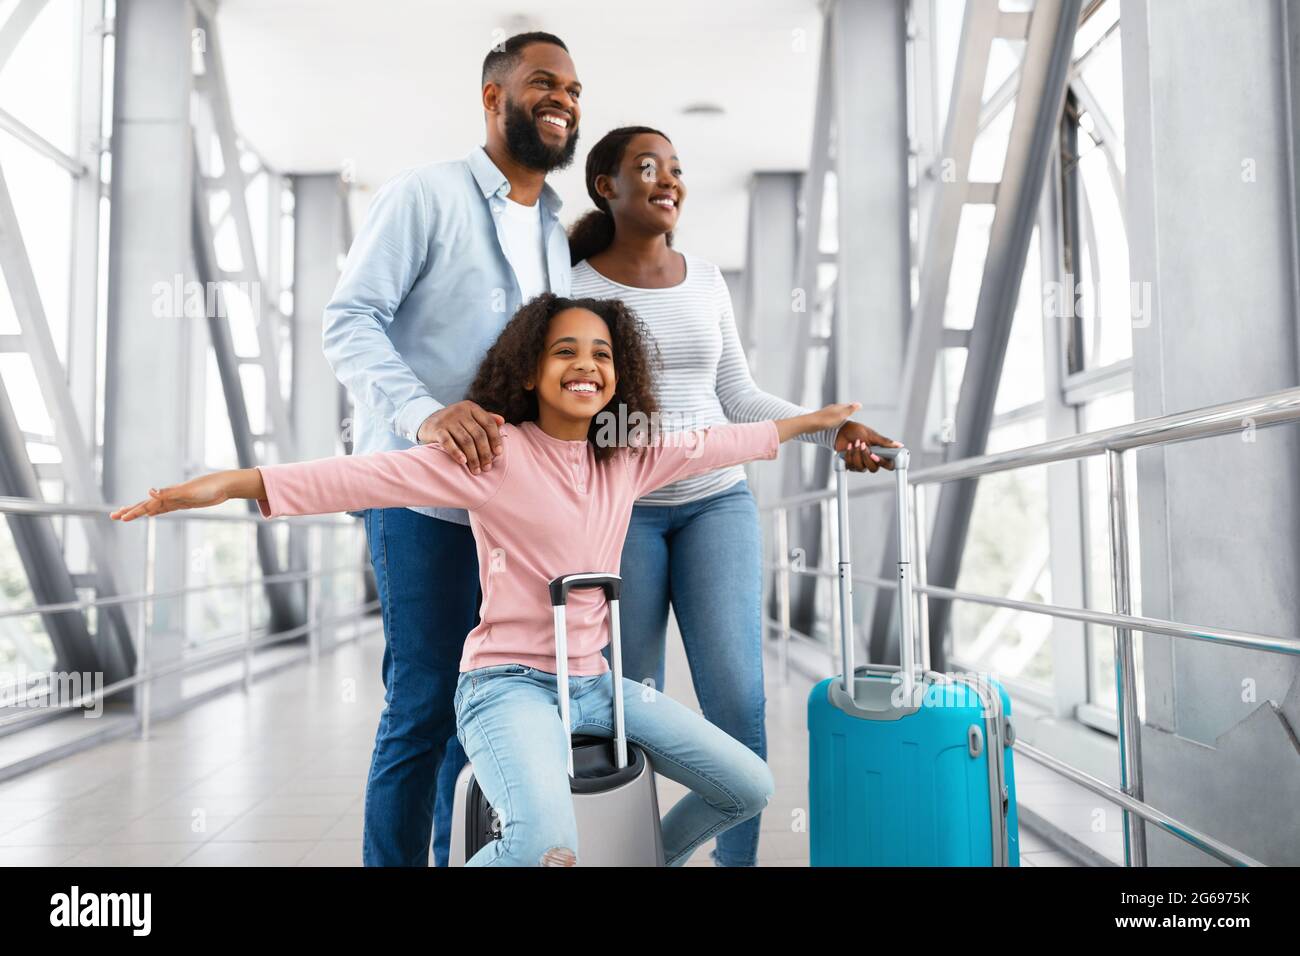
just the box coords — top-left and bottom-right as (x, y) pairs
(112, 294), (855, 866)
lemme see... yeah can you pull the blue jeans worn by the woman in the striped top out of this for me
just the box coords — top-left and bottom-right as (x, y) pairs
(606, 481), (767, 866)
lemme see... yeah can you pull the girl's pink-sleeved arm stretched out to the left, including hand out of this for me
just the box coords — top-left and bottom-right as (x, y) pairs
(109, 425), (510, 522)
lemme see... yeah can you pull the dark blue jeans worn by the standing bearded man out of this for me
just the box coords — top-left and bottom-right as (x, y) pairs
(361, 507), (482, 866)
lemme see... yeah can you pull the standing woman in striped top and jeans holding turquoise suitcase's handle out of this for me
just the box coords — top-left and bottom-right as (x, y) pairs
(569, 126), (898, 866)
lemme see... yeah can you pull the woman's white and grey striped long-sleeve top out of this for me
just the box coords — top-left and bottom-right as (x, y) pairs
(571, 252), (839, 506)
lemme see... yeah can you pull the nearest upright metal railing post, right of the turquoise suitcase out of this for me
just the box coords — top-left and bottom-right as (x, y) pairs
(1106, 449), (1147, 866)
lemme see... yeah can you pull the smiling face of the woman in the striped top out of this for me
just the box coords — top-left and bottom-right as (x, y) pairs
(595, 133), (686, 233)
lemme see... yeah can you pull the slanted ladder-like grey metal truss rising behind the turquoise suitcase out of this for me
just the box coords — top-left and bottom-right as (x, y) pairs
(870, 0), (1096, 670)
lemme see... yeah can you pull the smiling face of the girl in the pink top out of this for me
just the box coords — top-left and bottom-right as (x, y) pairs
(524, 308), (618, 423)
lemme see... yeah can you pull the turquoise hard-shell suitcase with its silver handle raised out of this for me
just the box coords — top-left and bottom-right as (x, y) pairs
(807, 449), (1021, 866)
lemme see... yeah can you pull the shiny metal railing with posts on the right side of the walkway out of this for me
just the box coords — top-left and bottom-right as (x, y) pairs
(759, 388), (1300, 866)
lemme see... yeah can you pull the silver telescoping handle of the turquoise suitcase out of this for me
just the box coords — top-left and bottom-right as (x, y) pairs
(835, 447), (917, 701)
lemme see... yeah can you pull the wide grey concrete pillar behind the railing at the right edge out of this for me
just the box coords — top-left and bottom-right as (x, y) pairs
(1121, 0), (1300, 866)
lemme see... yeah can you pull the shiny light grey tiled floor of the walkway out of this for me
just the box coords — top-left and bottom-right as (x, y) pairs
(0, 613), (1074, 866)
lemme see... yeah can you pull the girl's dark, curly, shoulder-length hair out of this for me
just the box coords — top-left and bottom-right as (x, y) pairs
(465, 293), (663, 462)
